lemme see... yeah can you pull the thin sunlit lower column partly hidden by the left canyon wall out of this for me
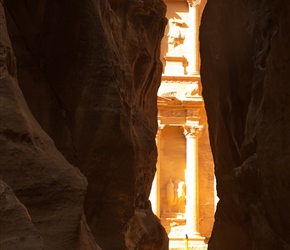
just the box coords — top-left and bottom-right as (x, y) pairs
(149, 124), (164, 217)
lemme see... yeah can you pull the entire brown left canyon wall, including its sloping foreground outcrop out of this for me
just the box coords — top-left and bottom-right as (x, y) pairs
(0, 0), (168, 250)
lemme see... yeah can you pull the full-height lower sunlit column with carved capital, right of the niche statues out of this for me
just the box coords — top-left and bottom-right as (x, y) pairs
(184, 125), (202, 238)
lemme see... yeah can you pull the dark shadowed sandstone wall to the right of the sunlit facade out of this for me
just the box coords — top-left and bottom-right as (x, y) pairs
(200, 0), (290, 250)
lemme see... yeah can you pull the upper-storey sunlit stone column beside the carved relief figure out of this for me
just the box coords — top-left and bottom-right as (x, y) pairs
(187, 0), (201, 75)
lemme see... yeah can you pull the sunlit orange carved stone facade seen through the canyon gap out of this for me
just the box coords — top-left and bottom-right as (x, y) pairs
(150, 0), (216, 249)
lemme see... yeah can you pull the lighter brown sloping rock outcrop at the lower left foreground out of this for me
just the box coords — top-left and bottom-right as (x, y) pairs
(0, 1), (101, 250)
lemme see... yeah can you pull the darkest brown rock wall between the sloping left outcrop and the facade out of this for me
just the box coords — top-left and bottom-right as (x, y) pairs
(4, 0), (168, 250)
